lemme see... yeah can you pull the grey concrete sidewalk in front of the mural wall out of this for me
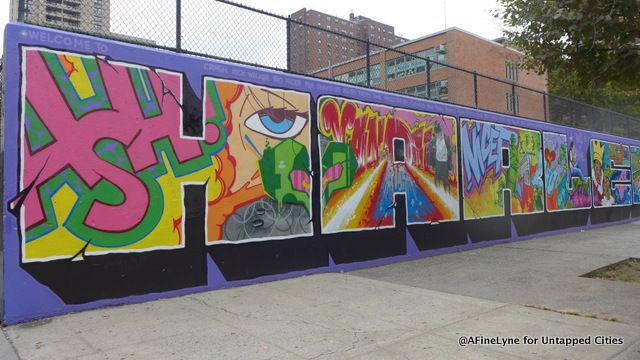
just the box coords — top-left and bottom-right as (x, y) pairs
(0, 223), (640, 360)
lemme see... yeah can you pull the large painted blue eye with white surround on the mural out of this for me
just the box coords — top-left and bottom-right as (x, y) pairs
(244, 107), (307, 139)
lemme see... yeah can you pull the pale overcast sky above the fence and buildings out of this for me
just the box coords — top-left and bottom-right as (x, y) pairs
(0, 0), (502, 58)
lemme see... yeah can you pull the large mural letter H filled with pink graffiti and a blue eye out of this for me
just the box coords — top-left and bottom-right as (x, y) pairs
(21, 47), (312, 261)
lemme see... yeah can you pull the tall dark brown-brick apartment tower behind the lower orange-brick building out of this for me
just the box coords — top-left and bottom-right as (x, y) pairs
(289, 8), (407, 73)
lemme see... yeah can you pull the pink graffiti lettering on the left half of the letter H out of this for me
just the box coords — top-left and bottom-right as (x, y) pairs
(23, 50), (218, 232)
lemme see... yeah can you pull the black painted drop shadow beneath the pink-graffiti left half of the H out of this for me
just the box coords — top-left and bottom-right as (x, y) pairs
(21, 185), (207, 304)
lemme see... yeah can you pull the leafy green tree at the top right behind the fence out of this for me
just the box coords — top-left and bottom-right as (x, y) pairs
(496, 0), (640, 117)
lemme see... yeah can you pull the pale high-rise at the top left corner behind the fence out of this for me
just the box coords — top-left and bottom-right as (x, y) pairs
(11, 0), (110, 34)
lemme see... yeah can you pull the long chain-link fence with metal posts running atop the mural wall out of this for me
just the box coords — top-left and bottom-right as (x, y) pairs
(14, 0), (640, 138)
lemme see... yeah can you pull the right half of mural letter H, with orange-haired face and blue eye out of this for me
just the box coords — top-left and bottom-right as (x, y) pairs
(203, 78), (313, 244)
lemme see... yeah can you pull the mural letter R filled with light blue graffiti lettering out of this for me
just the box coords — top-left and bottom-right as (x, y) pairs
(460, 119), (544, 219)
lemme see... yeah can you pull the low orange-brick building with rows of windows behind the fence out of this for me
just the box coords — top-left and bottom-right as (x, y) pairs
(307, 27), (547, 119)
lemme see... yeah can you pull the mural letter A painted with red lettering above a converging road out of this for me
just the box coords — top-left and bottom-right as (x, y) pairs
(318, 97), (459, 233)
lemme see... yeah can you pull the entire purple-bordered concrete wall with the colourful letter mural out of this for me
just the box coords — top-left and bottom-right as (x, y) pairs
(2, 24), (640, 323)
